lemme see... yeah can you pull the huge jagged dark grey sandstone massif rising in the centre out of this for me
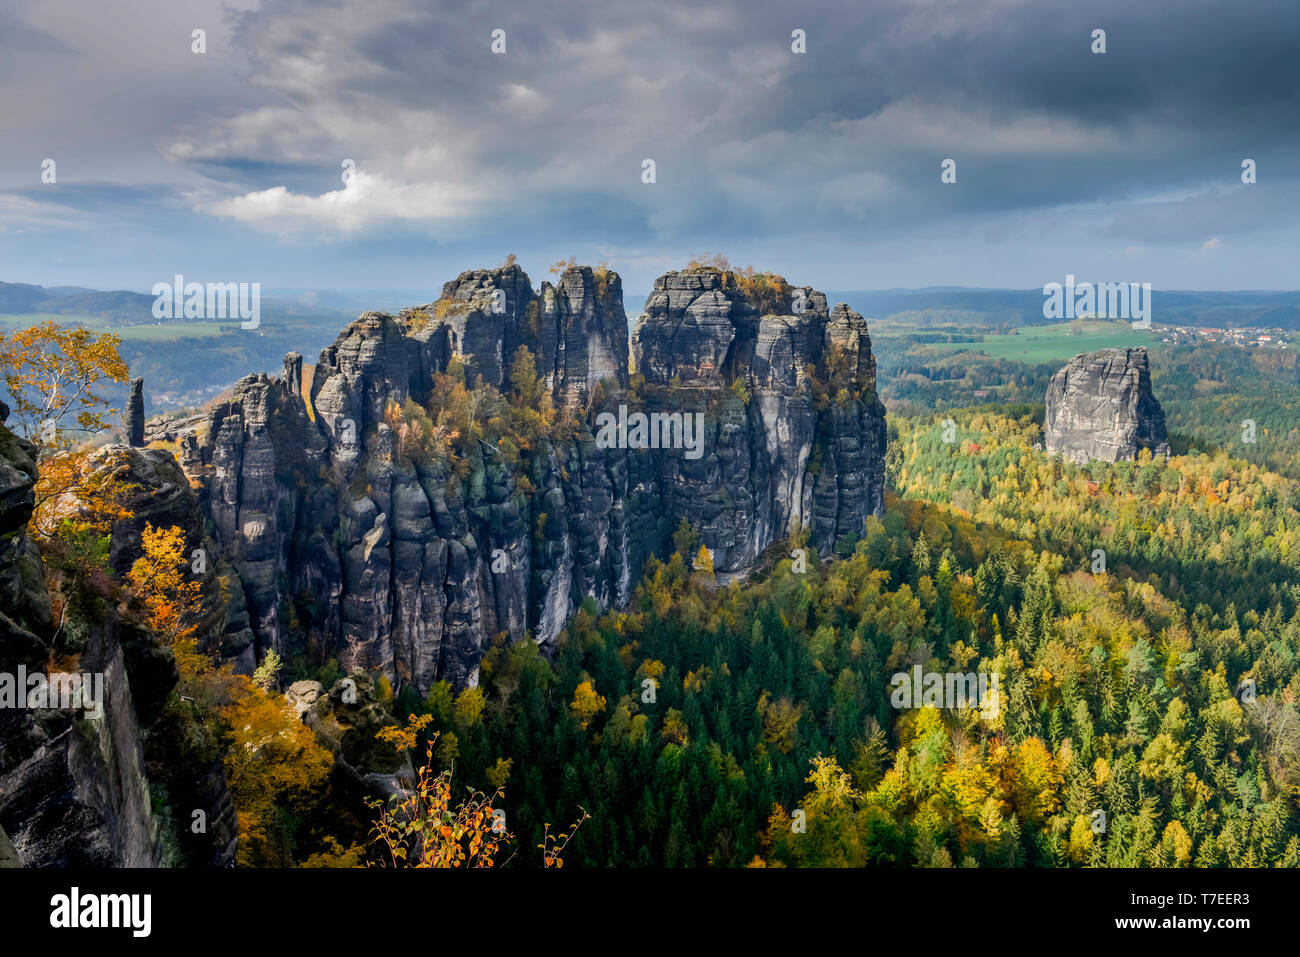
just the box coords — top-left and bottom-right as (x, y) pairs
(170, 265), (885, 692)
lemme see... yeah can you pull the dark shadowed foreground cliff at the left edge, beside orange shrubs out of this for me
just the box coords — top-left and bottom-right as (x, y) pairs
(0, 403), (235, 867)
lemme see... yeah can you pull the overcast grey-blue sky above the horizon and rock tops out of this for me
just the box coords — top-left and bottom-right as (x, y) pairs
(0, 0), (1300, 295)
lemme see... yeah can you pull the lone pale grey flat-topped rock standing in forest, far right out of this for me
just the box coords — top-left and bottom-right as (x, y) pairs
(1045, 347), (1169, 464)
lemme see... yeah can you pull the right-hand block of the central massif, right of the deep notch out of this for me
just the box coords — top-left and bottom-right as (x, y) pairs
(632, 269), (885, 573)
